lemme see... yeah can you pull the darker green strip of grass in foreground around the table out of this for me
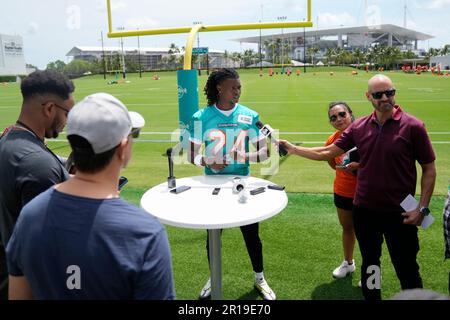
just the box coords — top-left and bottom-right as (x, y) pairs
(121, 187), (448, 300)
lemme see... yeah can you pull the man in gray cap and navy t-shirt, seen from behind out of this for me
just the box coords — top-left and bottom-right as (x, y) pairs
(6, 93), (175, 300)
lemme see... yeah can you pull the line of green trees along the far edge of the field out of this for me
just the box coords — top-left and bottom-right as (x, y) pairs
(47, 39), (450, 78)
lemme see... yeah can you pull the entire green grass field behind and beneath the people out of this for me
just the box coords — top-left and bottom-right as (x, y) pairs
(0, 68), (450, 299)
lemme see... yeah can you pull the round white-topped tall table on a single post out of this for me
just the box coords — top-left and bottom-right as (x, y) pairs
(141, 175), (288, 299)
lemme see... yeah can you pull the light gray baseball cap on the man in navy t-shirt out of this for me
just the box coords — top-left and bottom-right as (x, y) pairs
(67, 93), (145, 154)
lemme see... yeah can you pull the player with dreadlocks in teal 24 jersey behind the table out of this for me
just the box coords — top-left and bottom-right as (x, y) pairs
(190, 68), (276, 300)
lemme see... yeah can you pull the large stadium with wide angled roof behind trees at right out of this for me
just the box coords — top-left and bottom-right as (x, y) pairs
(234, 24), (433, 61)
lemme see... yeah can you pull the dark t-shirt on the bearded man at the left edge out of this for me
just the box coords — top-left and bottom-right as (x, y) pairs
(0, 129), (69, 247)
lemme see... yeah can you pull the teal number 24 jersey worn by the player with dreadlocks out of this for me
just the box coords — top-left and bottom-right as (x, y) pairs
(189, 104), (264, 176)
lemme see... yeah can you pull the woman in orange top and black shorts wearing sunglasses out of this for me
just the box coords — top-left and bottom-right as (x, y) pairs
(326, 102), (359, 278)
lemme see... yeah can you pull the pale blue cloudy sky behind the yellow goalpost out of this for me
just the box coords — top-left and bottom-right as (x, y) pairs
(0, 0), (450, 68)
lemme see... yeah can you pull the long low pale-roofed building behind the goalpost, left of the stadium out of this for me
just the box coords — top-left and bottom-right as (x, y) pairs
(66, 46), (233, 70)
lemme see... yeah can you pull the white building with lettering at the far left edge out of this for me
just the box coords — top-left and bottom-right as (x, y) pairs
(0, 34), (27, 76)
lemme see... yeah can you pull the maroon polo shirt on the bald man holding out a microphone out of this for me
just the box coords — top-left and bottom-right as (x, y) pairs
(334, 106), (436, 211)
